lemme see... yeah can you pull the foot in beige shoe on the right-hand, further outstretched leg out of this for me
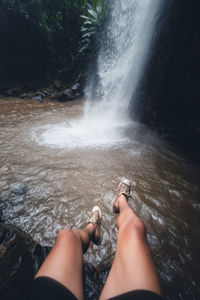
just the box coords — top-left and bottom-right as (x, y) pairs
(113, 178), (131, 214)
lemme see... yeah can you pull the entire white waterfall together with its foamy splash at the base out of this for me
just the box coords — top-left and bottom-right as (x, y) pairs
(34, 0), (162, 148)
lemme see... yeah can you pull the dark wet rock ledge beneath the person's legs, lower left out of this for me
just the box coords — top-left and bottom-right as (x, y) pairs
(0, 223), (102, 300)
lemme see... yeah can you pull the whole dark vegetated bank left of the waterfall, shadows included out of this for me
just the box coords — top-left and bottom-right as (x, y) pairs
(0, 0), (107, 93)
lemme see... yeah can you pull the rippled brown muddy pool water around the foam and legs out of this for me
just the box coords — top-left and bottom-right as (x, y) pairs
(0, 99), (200, 299)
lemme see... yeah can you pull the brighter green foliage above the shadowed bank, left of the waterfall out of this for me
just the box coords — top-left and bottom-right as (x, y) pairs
(0, 0), (108, 84)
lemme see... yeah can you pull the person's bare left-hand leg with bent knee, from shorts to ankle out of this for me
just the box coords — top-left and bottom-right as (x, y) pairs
(35, 223), (99, 299)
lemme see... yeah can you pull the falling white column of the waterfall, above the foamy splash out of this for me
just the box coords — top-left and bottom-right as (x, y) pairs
(85, 0), (163, 122)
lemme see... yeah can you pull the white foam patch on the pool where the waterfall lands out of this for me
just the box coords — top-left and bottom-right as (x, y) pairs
(32, 113), (132, 149)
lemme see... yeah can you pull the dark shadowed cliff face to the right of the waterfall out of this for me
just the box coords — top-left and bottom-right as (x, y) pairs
(134, 0), (200, 162)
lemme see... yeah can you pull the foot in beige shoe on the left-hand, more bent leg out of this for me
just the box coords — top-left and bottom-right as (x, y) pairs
(89, 206), (102, 245)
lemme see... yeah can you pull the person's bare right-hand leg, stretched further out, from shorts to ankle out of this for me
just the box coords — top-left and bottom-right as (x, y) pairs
(100, 195), (160, 300)
